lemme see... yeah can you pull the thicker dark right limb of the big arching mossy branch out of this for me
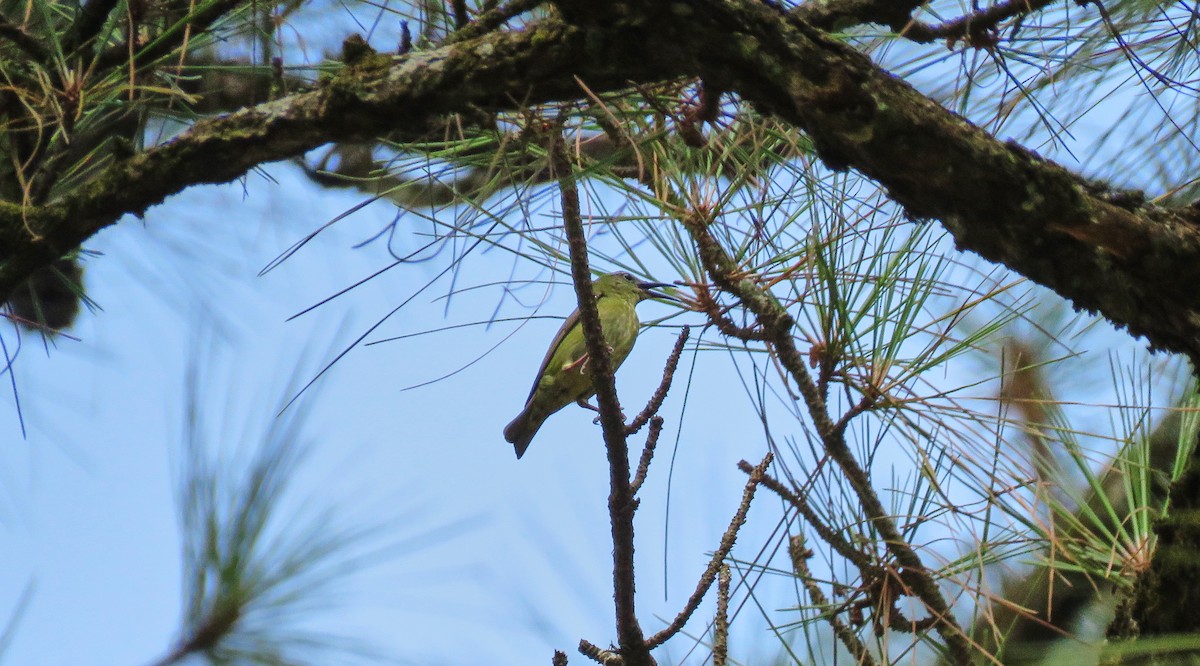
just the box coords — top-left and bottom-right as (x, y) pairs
(558, 0), (1200, 361)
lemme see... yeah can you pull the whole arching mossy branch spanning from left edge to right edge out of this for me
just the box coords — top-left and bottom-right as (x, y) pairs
(7, 0), (1200, 365)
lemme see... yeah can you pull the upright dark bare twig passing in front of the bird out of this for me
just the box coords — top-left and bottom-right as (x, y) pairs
(550, 126), (653, 666)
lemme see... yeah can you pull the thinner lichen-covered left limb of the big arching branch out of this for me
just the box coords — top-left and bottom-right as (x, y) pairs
(0, 20), (673, 300)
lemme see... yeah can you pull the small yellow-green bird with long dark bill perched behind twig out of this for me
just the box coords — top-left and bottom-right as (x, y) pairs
(504, 272), (671, 458)
